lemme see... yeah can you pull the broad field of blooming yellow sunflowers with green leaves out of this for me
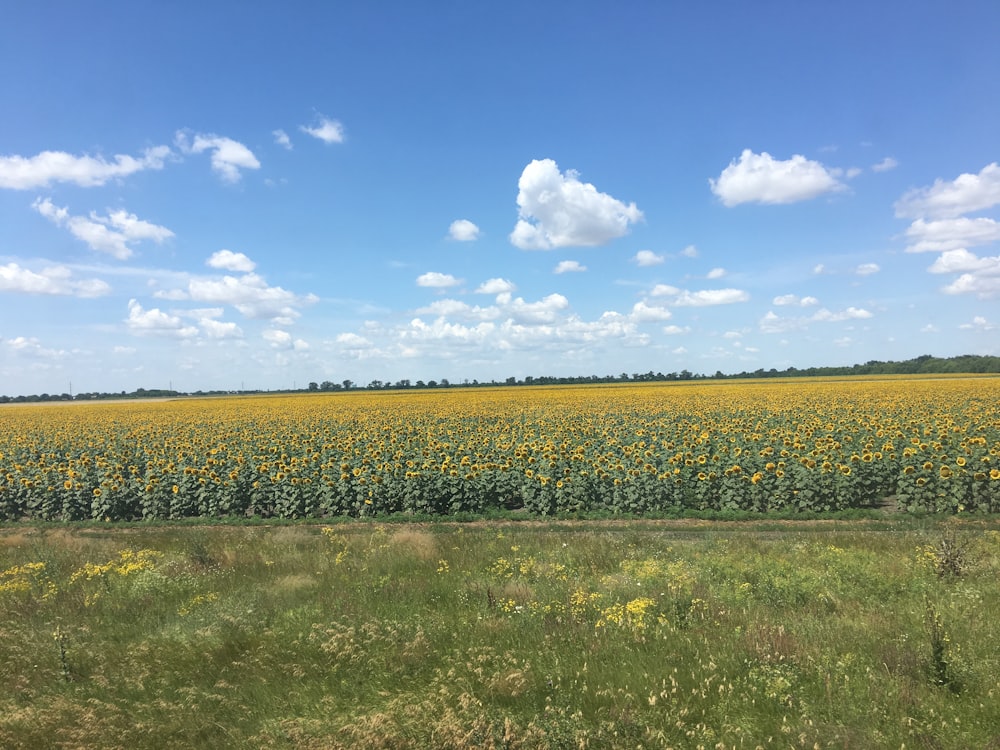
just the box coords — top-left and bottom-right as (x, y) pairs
(0, 377), (1000, 521)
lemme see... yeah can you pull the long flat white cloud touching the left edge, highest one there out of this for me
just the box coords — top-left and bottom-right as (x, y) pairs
(0, 146), (170, 190)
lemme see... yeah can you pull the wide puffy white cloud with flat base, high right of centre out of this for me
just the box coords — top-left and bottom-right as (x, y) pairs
(708, 149), (844, 206)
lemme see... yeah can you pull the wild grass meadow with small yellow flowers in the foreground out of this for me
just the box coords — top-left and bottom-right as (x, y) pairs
(0, 514), (1000, 750)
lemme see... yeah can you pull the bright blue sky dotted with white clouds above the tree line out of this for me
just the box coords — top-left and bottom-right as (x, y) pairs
(0, 0), (1000, 395)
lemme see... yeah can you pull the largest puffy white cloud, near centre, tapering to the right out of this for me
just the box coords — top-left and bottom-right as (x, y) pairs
(510, 159), (642, 250)
